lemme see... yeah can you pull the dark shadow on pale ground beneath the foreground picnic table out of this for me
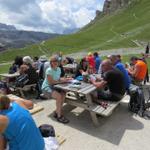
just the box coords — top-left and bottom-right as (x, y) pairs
(49, 103), (144, 145)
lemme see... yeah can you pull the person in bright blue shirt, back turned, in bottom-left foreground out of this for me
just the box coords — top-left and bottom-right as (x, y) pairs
(0, 95), (45, 150)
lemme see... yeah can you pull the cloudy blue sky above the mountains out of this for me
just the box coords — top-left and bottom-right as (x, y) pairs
(0, 0), (104, 33)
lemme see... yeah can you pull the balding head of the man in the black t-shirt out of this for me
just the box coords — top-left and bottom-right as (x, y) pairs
(101, 59), (112, 72)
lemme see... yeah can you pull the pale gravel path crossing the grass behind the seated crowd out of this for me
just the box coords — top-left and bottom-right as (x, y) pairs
(0, 47), (145, 66)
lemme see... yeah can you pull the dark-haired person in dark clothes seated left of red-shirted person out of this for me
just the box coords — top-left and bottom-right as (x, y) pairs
(75, 58), (88, 78)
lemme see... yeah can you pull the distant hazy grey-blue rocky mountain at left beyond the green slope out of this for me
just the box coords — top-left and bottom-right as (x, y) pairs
(0, 23), (59, 51)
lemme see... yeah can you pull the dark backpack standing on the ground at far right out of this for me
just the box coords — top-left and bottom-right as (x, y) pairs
(128, 85), (145, 117)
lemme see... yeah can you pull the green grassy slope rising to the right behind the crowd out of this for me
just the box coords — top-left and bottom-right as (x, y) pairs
(0, 0), (150, 61)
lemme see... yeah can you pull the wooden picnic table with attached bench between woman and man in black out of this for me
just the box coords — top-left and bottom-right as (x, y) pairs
(54, 82), (120, 126)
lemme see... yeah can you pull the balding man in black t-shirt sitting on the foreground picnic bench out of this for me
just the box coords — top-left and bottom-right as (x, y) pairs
(91, 59), (126, 101)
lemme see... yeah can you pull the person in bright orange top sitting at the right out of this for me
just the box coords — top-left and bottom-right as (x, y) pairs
(128, 56), (147, 84)
